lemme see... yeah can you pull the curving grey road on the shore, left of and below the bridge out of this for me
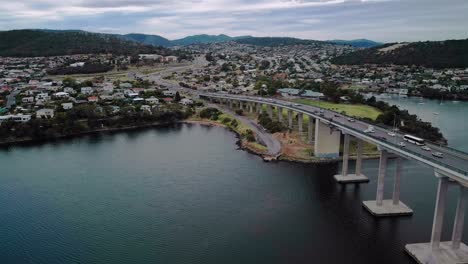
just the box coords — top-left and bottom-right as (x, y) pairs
(209, 104), (281, 158)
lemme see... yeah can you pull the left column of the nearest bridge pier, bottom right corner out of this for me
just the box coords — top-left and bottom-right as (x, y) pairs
(431, 177), (449, 250)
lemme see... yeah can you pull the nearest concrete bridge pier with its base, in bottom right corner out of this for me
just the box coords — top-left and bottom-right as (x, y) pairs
(405, 177), (468, 264)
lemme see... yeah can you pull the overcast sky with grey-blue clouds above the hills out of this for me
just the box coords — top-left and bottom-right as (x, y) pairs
(0, 0), (468, 42)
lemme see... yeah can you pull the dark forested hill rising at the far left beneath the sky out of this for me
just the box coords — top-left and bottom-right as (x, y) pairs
(0, 30), (168, 57)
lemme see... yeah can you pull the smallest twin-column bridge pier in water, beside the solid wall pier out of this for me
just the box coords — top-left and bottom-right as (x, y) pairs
(334, 134), (369, 184)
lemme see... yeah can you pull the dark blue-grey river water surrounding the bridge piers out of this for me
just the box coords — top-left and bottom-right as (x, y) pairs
(0, 98), (468, 264)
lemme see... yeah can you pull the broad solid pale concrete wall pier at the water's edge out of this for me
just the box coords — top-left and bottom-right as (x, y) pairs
(314, 119), (341, 158)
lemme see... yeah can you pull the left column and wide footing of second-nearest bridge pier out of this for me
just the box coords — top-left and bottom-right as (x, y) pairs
(363, 150), (413, 216)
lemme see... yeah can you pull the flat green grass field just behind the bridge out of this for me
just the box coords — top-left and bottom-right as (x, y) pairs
(294, 99), (382, 120)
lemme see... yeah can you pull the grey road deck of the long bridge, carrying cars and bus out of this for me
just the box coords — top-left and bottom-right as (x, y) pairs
(202, 94), (468, 183)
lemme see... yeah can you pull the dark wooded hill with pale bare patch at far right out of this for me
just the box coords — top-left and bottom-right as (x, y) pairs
(332, 39), (468, 68)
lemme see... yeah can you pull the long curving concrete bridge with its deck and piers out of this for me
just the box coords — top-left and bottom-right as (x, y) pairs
(199, 93), (468, 264)
